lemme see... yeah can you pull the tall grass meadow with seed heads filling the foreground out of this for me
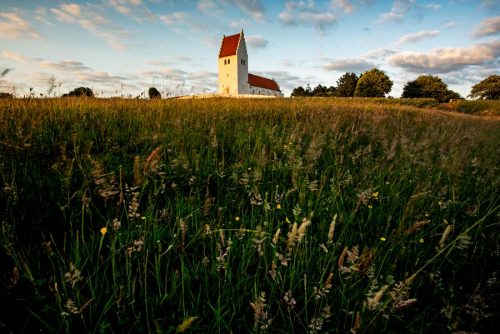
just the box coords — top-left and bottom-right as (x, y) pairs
(0, 98), (500, 333)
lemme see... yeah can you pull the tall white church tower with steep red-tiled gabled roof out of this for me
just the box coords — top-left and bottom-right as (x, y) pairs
(219, 30), (250, 95)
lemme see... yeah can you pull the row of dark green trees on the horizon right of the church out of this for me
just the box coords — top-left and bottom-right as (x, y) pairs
(291, 68), (500, 103)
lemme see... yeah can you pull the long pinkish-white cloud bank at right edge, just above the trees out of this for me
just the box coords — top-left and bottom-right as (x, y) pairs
(389, 40), (500, 73)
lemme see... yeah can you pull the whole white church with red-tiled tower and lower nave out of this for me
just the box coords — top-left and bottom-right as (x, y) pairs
(219, 30), (283, 97)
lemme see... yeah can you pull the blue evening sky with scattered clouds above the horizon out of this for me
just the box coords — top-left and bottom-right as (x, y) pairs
(0, 0), (500, 97)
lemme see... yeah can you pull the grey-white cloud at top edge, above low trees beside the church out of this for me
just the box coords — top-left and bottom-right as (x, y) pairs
(278, 0), (338, 31)
